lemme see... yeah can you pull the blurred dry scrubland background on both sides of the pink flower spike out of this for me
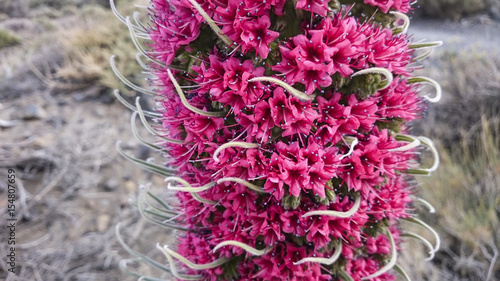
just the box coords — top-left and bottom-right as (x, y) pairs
(0, 0), (500, 281)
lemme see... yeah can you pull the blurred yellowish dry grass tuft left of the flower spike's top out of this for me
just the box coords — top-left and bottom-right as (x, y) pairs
(56, 1), (148, 91)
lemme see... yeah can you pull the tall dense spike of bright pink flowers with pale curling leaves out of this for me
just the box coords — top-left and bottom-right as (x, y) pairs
(114, 0), (442, 280)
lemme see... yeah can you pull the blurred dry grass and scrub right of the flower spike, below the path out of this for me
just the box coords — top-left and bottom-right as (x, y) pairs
(404, 50), (500, 281)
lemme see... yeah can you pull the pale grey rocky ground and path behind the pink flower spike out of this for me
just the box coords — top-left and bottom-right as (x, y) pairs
(0, 2), (500, 280)
